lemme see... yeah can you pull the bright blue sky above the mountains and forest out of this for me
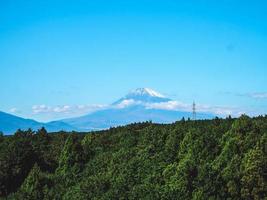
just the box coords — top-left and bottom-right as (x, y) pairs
(0, 0), (267, 121)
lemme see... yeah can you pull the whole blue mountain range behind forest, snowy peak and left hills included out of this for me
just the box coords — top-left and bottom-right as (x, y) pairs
(0, 88), (214, 134)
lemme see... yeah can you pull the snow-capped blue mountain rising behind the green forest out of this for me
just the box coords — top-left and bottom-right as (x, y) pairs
(61, 88), (213, 131)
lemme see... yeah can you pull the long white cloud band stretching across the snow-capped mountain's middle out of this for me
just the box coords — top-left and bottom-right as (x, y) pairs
(29, 99), (262, 119)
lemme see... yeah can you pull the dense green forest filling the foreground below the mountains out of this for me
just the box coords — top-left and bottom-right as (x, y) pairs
(0, 116), (267, 200)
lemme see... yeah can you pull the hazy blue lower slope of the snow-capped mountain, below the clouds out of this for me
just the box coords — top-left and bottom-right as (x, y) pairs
(63, 106), (212, 130)
